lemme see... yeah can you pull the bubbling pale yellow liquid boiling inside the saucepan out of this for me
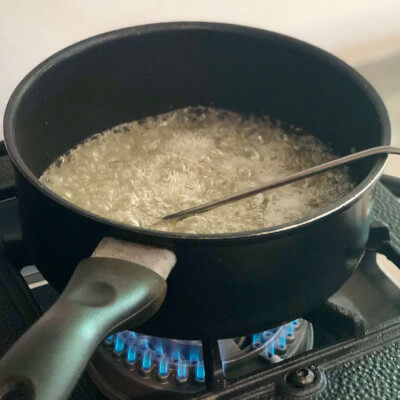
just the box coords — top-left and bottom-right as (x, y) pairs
(40, 107), (354, 234)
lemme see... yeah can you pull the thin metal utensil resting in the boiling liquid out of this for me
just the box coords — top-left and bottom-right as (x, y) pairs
(163, 146), (400, 219)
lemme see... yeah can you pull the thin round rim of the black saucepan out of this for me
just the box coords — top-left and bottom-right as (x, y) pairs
(4, 22), (390, 243)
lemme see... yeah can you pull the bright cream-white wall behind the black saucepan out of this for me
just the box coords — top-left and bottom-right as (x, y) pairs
(0, 0), (400, 139)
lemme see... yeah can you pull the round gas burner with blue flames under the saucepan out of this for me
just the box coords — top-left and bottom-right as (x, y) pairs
(91, 319), (313, 398)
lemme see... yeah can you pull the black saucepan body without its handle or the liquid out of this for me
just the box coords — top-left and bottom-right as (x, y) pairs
(0, 22), (390, 400)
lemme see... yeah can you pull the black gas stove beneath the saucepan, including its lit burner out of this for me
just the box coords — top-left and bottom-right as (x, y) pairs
(0, 142), (400, 400)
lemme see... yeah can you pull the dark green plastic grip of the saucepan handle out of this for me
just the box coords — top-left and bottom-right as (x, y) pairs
(0, 257), (167, 400)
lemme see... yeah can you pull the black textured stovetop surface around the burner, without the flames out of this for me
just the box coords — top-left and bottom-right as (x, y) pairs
(0, 142), (400, 400)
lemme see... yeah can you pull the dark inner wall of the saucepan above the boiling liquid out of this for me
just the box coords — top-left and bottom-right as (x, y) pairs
(5, 23), (389, 241)
